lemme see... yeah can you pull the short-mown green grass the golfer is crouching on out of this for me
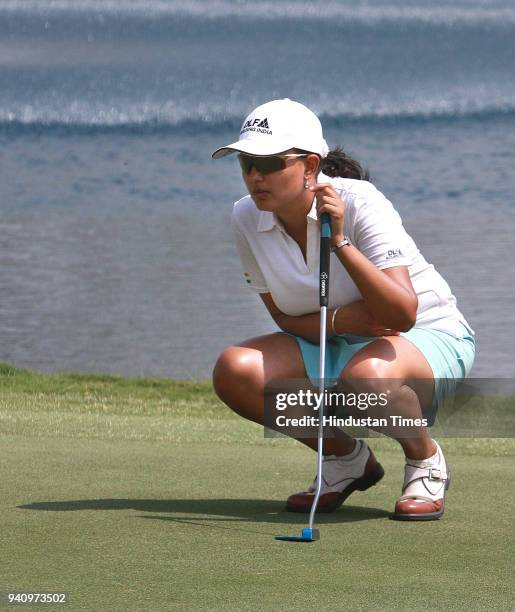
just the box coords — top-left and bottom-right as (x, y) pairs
(0, 364), (515, 611)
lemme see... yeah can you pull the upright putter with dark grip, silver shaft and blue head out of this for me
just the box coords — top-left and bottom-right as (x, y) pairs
(275, 213), (331, 542)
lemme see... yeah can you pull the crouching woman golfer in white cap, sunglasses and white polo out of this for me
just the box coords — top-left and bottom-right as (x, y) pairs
(213, 99), (474, 520)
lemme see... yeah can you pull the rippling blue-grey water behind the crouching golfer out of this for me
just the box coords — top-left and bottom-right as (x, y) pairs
(0, 0), (515, 378)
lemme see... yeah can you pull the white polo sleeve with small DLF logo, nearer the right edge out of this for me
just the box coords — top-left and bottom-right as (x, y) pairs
(352, 189), (413, 270)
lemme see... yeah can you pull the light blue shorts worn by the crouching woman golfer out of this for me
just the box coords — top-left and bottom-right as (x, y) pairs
(293, 324), (475, 408)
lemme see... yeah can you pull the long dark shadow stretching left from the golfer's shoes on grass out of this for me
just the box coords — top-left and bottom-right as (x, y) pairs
(18, 499), (390, 525)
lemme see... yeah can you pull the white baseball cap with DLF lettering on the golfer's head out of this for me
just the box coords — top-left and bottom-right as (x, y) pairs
(212, 98), (329, 159)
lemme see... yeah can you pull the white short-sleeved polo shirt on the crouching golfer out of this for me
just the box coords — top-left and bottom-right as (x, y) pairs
(232, 174), (474, 337)
